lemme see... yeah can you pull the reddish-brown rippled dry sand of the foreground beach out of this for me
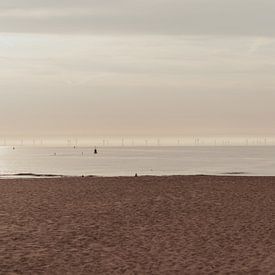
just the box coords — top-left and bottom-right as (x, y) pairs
(0, 176), (275, 274)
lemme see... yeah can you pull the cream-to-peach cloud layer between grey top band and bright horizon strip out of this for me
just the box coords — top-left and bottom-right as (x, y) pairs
(0, 34), (275, 135)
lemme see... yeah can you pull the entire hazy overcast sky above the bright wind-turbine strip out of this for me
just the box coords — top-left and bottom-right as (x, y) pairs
(0, 0), (275, 136)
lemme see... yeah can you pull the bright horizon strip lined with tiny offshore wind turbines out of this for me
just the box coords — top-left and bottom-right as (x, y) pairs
(0, 135), (275, 147)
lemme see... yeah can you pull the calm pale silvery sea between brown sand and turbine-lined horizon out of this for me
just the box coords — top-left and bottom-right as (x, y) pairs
(0, 146), (275, 177)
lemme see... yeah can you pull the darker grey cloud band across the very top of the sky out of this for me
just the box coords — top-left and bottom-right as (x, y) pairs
(0, 0), (275, 36)
